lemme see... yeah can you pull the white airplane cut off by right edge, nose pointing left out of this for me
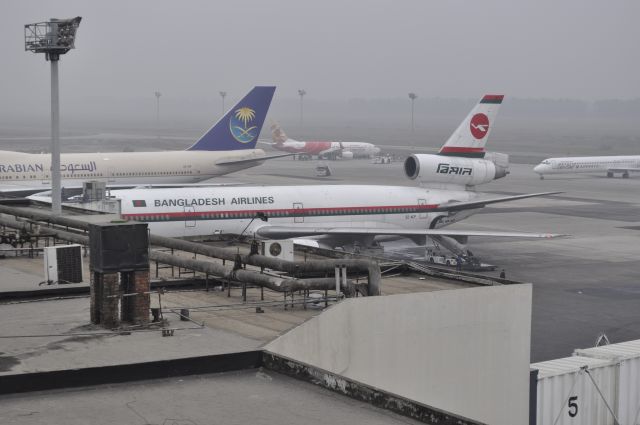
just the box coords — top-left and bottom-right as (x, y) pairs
(533, 155), (640, 179)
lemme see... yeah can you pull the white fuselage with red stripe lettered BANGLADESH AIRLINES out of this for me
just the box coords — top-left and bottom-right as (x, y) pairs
(111, 185), (477, 237)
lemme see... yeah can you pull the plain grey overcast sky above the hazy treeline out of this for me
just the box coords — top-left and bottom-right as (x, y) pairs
(0, 0), (640, 112)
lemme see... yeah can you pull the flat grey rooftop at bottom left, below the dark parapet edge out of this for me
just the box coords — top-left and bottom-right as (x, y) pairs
(0, 369), (418, 425)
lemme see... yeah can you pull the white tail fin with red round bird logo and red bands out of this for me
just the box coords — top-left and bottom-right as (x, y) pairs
(438, 94), (504, 158)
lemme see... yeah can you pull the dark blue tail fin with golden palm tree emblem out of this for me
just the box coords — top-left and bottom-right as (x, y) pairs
(187, 86), (276, 151)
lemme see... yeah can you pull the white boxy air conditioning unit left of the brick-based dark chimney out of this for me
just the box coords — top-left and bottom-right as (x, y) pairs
(44, 245), (82, 283)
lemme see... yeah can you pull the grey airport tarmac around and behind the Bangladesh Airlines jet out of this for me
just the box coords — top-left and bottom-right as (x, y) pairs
(216, 158), (640, 362)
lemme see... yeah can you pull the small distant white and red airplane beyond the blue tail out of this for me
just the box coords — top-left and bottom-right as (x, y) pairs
(271, 123), (380, 159)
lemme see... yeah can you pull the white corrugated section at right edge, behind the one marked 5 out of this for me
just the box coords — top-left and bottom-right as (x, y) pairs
(574, 340), (640, 425)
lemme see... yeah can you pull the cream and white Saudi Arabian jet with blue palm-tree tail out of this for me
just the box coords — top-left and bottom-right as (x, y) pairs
(0, 87), (285, 193)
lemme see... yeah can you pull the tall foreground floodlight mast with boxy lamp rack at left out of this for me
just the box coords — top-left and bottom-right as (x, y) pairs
(24, 16), (82, 215)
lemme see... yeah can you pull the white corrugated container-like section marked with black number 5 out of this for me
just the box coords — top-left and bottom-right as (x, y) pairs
(531, 356), (617, 425)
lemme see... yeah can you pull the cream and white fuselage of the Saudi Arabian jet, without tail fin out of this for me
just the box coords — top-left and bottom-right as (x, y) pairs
(0, 149), (265, 189)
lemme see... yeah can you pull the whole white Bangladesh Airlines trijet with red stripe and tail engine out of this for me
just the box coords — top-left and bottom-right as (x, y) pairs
(42, 95), (555, 253)
